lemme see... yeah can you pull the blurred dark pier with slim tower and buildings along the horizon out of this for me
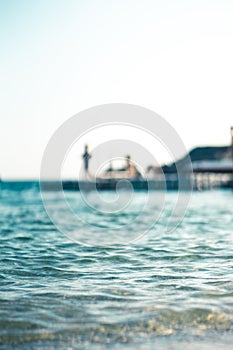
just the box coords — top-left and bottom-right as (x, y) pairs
(39, 127), (233, 191)
